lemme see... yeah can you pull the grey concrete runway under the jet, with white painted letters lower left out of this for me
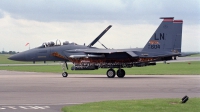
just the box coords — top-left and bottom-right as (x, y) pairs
(0, 70), (200, 112)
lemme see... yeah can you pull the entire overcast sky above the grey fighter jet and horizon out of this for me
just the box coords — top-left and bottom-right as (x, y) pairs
(0, 0), (200, 52)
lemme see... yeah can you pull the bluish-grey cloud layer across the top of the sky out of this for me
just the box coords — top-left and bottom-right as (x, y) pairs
(0, 0), (200, 24)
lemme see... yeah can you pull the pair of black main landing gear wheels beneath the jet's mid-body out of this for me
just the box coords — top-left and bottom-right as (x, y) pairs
(107, 68), (126, 78)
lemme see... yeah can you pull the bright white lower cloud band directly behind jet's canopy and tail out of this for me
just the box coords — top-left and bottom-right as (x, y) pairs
(0, 13), (200, 51)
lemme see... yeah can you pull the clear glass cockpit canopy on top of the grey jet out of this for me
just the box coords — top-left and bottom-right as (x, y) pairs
(39, 39), (77, 48)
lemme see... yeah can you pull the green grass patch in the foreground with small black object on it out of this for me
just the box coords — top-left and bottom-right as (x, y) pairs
(62, 98), (200, 112)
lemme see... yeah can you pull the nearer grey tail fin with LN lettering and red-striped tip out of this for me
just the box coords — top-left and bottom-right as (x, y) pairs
(142, 17), (174, 52)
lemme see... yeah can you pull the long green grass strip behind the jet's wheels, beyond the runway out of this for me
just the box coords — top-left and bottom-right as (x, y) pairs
(0, 61), (200, 75)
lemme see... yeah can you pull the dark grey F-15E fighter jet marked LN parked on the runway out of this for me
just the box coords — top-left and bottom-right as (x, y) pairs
(9, 17), (183, 78)
